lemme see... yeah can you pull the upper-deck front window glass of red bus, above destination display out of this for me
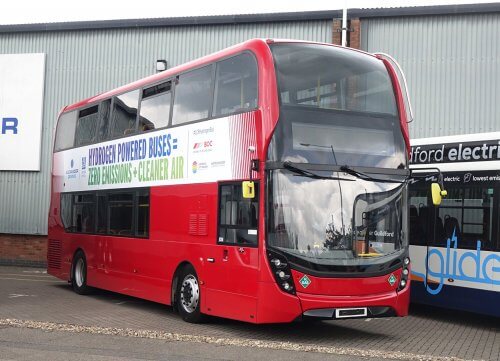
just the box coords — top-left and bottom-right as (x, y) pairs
(271, 44), (397, 115)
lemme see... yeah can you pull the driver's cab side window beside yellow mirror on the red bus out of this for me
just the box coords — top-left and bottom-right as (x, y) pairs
(218, 183), (259, 245)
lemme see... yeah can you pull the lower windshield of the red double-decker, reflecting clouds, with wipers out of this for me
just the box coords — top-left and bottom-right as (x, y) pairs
(268, 170), (408, 272)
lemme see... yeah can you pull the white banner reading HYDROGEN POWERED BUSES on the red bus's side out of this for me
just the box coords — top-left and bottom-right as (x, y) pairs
(53, 118), (233, 192)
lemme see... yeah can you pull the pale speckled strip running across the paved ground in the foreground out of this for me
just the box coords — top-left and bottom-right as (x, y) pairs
(0, 318), (478, 361)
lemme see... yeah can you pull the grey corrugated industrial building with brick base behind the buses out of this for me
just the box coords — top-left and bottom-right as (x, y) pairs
(0, 3), (500, 265)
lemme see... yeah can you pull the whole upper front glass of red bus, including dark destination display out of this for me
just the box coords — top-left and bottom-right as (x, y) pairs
(269, 43), (406, 168)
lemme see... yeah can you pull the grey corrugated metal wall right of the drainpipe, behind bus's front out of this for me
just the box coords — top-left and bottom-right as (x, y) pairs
(361, 13), (500, 138)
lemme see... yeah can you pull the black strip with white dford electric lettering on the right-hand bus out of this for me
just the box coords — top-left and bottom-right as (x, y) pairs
(410, 139), (500, 164)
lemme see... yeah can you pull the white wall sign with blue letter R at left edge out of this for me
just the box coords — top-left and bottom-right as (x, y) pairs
(0, 54), (45, 171)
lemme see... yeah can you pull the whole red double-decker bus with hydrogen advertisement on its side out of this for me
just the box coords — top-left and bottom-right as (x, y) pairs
(47, 39), (410, 323)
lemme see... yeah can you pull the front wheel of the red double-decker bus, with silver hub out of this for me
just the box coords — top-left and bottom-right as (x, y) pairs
(177, 265), (203, 323)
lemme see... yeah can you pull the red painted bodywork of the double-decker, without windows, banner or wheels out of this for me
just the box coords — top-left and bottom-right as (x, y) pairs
(48, 40), (409, 323)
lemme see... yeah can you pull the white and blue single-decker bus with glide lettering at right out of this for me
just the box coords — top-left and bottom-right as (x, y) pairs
(410, 132), (500, 317)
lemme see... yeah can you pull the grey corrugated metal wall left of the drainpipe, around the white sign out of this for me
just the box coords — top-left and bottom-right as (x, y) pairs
(0, 21), (332, 234)
